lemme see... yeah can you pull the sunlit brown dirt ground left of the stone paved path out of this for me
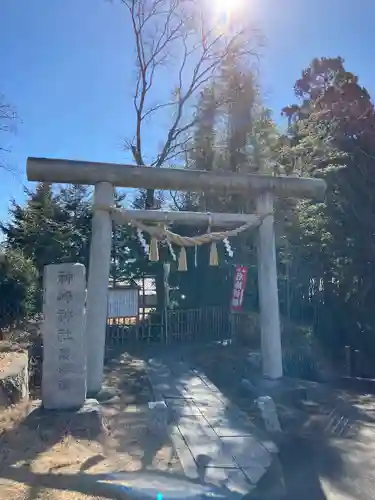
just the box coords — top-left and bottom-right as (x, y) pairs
(0, 354), (181, 500)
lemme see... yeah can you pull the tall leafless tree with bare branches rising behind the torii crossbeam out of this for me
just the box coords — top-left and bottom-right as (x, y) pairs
(121, 0), (259, 208)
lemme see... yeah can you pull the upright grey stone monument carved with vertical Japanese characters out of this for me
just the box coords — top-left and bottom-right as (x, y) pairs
(42, 264), (86, 410)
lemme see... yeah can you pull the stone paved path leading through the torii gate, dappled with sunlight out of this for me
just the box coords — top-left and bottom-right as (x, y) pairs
(148, 358), (277, 496)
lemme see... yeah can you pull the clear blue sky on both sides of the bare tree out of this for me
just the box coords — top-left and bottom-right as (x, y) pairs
(0, 0), (375, 218)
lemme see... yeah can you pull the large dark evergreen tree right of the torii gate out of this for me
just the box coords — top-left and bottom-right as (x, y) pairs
(283, 58), (375, 370)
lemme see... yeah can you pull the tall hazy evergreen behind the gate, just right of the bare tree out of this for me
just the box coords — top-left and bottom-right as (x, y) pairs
(172, 64), (280, 307)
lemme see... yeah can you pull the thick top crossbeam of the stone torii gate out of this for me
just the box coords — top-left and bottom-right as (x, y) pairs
(27, 158), (326, 201)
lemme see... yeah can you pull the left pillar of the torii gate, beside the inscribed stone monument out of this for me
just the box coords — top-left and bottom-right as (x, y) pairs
(86, 182), (114, 394)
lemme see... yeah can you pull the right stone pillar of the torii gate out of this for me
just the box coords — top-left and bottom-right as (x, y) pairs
(256, 192), (283, 379)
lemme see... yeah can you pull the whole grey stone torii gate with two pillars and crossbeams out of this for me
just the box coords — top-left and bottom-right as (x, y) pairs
(27, 158), (326, 394)
